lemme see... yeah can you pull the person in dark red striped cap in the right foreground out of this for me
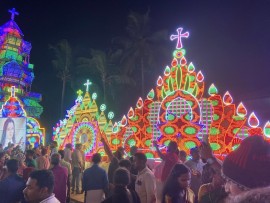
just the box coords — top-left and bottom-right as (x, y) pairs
(200, 135), (270, 199)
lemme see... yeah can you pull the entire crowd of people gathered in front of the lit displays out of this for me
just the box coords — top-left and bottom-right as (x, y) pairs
(0, 135), (270, 203)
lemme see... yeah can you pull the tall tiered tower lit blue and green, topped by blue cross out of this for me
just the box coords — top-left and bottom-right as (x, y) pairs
(0, 8), (43, 118)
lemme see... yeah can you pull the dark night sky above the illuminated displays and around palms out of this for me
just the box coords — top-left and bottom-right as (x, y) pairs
(0, 0), (270, 137)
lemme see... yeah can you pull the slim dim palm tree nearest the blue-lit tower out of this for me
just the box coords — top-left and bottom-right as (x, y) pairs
(49, 39), (72, 116)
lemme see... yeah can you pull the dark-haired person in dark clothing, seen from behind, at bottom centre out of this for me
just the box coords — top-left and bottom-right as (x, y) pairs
(102, 168), (141, 203)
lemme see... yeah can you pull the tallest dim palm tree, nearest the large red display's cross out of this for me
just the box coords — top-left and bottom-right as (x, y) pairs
(114, 10), (169, 96)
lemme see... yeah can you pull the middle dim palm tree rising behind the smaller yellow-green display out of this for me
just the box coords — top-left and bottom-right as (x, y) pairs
(77, 49), (135, 103)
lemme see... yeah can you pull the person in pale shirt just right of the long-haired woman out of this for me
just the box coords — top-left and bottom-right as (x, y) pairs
(185, 147), (204, 199)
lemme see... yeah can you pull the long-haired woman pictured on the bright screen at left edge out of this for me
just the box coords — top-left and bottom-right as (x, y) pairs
(1, 118), (16, 148)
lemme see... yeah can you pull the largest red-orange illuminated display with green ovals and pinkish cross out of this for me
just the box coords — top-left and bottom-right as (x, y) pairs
(110, 25), (270, 159)
